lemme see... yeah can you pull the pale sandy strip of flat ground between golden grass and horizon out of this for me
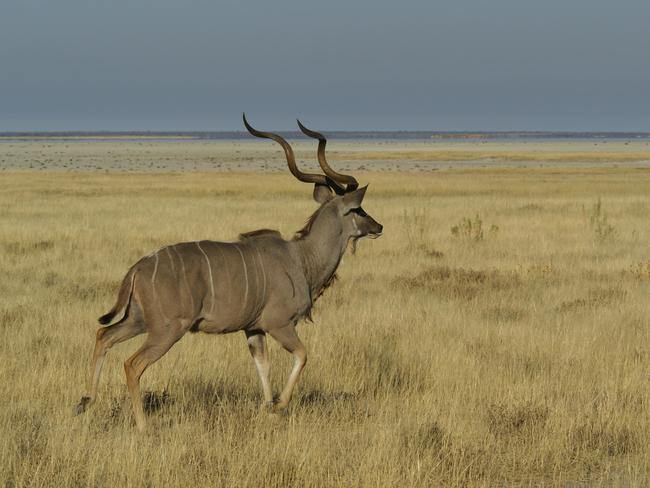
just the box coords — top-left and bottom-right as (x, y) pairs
(0, 140), (650, 172)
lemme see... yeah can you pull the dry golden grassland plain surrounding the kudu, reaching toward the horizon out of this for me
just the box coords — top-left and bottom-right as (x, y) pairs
(0, 141), (650, 487)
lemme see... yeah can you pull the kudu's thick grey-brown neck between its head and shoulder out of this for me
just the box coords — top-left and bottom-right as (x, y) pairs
(295, 207), (348, 298)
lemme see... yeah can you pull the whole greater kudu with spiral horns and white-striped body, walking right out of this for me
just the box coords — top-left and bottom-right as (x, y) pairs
(75, 116), (382, 430)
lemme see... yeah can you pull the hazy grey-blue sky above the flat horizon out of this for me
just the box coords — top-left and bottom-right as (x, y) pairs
(0, 0), (650, 131)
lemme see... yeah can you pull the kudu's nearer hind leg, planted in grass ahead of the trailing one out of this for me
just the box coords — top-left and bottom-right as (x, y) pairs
(124, 327), (183, 431)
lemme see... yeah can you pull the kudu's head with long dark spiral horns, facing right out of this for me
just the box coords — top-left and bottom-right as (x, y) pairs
(244, 115), (383, 245)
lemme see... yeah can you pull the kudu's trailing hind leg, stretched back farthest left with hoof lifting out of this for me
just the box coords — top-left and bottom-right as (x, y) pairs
(75, 313), (145, 415)
